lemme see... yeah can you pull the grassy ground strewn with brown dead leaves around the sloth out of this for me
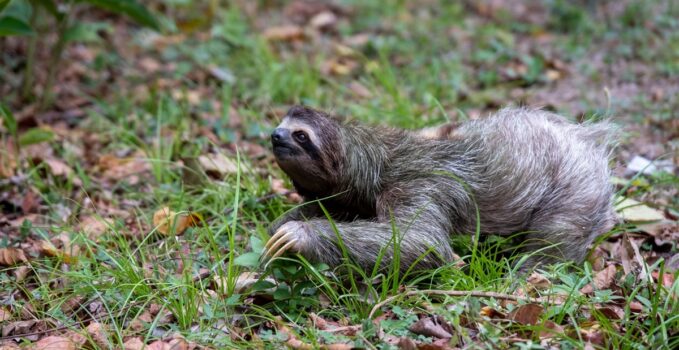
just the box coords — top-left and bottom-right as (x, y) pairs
(0, 0), (679, 349)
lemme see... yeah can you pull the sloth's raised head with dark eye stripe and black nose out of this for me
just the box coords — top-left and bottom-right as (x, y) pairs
(271, 106), (342, 195)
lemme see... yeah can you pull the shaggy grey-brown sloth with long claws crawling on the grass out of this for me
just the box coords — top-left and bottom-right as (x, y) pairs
(263, 106), (616, 272)
